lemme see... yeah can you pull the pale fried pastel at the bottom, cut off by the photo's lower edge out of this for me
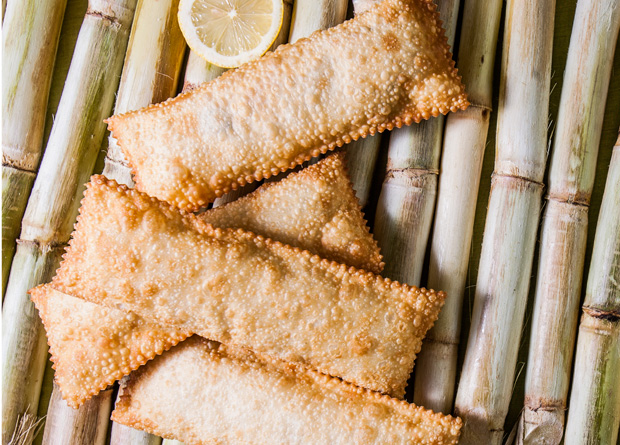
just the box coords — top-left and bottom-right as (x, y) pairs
(112, 337), (461, 445)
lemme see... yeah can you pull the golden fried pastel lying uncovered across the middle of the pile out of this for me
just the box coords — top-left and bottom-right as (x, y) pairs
(52, 176), (445, 396)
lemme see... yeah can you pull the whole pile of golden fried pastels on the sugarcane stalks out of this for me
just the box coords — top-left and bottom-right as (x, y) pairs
(31, 0), (467, 444)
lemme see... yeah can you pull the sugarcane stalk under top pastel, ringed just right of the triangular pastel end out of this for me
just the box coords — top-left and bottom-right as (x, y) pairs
(374, 0), (460, 286)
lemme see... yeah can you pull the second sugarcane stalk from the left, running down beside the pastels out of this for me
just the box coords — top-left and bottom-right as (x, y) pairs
(2, 0), (135, 442)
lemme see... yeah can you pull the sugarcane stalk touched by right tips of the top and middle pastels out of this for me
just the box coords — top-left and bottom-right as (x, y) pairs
(413, 0), (502, 413)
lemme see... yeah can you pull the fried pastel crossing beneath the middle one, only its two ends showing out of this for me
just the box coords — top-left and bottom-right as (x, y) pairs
(35, 154), (382, 408)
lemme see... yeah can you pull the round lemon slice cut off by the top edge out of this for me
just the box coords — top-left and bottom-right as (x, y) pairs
(179, 0), (283, 68)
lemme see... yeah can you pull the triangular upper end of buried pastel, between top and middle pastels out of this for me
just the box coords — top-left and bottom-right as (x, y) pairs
(200, 153), (383, 274)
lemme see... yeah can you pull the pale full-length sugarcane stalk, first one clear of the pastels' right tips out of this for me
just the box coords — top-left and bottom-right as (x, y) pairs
(455, 0), (555, 444)
